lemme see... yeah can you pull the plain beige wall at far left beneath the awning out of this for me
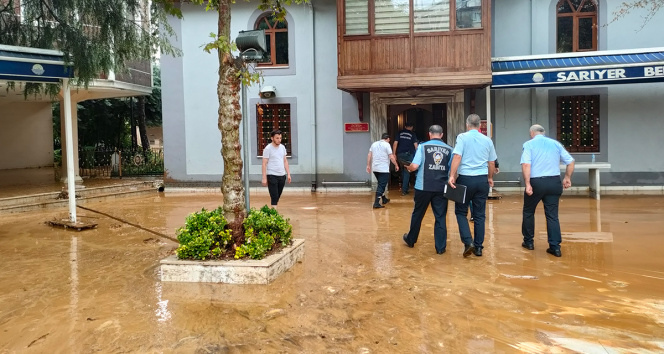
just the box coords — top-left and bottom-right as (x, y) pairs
(0, 102), (53, 170)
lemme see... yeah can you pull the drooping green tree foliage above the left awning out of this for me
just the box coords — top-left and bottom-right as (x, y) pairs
(0, 0), (182, 94)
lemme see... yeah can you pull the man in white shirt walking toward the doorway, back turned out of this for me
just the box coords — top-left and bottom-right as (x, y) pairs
(367, 133), (399, 209)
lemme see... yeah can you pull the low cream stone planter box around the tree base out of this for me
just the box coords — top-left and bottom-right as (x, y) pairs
(161, 239), (304, 284)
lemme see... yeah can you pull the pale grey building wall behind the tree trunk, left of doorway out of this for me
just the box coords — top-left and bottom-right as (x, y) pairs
(162, 0), (370, 184)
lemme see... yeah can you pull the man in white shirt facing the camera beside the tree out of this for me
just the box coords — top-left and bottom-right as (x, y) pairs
(262, 130), (291, 209)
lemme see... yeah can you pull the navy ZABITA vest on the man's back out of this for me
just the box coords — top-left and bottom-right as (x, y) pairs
(420, 139), (452, 192)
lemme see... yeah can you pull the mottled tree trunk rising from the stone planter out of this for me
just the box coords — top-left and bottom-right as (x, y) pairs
(217, 0), (247, 246)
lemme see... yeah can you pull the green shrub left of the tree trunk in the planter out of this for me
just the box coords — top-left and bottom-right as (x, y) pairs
(175, 207), (231, 259)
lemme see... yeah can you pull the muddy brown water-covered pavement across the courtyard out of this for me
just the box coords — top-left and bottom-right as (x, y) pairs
(0, 190), (664, 353)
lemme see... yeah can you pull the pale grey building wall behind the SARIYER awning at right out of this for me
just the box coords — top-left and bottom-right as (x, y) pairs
(492, 0), (664, 185)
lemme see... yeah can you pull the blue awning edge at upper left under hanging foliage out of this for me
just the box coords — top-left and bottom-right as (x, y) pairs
(0, 45), (74, 83)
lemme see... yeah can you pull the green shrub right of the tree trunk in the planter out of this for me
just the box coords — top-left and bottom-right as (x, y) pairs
(235, 205), (293, 259)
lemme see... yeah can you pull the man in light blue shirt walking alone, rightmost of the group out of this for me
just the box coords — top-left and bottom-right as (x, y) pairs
(521, 124), (574, 257)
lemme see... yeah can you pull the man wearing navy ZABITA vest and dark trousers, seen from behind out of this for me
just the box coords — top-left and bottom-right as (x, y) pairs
(403, 125), (452, 254)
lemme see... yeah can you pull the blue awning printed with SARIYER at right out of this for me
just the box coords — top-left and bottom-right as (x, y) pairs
(491, 48), (664, 89)
